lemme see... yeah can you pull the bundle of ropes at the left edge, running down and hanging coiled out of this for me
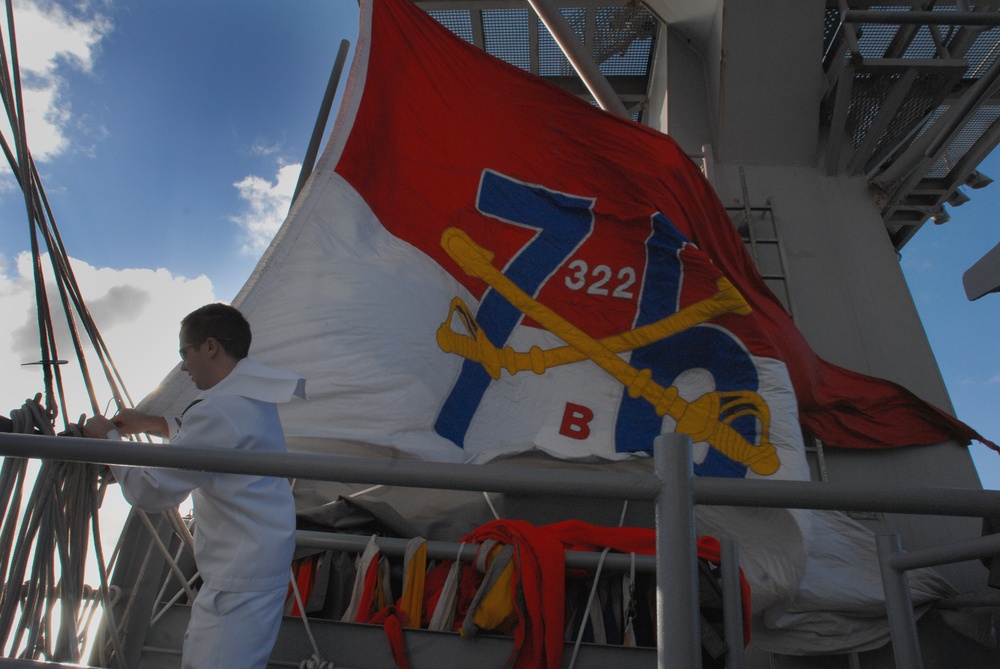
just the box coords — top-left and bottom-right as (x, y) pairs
(0, 2), (141, 666)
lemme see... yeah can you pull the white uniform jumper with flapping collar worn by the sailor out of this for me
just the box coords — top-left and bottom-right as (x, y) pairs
(112, 359), (305, 592)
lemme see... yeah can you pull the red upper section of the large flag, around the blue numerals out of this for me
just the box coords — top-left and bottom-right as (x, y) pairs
(337, 0), (997, 449)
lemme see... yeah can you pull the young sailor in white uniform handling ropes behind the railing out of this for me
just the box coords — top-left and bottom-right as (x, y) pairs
(84, 304), (305, 669)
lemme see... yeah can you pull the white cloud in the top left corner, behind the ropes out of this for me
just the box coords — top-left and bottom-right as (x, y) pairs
(0, 0), (111, 161)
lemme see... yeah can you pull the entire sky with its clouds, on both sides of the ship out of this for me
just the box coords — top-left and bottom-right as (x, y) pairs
(0, 0), (1000, 489)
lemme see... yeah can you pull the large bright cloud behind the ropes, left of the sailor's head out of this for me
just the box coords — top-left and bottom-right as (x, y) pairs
(0, 253), (215, 422)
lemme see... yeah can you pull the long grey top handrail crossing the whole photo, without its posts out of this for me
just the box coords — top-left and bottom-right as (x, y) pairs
(0, 434), (1000, 517)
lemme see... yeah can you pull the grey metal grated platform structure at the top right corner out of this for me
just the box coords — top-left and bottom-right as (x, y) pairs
(821, 0), (1000, 248)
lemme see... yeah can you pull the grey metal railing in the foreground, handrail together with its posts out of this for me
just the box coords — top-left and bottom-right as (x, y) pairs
(0, 434), (1000, 669)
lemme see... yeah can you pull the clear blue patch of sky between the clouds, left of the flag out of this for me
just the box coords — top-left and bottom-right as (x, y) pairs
(29, 0), (357, 297)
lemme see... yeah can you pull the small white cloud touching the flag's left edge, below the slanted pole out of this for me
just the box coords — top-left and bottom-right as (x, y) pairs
(232, 165), (302, 255)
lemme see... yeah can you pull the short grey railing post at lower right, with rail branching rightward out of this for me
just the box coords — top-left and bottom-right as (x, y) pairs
(875, 534), (924, 669)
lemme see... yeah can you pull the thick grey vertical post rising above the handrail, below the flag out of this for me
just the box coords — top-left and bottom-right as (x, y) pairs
(653, 433), (701, 669)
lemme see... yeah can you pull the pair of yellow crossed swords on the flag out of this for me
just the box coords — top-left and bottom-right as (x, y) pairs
(437, 228), (780, 476)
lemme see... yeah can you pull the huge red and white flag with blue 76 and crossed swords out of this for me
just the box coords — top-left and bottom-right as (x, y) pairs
(145, 0), (978, 652)
